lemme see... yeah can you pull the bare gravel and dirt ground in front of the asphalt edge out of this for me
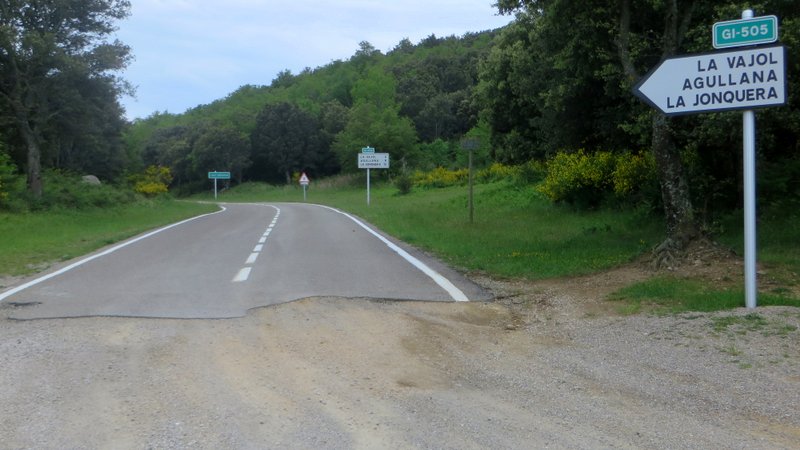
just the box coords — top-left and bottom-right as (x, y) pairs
(0, 268), (800, 449)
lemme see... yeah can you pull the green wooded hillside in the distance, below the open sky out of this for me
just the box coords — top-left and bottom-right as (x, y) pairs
(126, 32), (496, 192)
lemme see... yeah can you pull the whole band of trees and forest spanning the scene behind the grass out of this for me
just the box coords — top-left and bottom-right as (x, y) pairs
(0, 0), (800, 246)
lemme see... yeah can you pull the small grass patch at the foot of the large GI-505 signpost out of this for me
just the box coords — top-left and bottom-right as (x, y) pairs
(611, 277), (800, 314)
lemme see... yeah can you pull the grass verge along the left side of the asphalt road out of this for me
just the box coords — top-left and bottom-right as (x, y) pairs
(0, 200), (217, 276)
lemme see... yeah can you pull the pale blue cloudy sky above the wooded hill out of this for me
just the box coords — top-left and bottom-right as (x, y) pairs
(117, 0), (512, 119)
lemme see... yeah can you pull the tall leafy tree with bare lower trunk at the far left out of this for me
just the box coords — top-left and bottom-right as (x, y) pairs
(0, 0), (130, 196)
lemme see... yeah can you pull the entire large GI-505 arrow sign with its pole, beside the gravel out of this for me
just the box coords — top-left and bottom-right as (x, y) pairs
(633, 9), (787, 309)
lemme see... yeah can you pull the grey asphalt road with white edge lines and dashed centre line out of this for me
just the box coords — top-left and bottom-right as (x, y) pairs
(0, 204), (488, 319)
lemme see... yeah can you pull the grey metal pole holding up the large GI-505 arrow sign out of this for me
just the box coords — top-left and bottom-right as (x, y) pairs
(742, 9), (758, 309)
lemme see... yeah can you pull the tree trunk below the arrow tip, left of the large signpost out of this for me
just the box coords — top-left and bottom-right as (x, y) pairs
(653, 114), (699, 249)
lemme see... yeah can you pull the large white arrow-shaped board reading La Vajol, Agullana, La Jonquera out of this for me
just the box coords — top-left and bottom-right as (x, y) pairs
(633, 45), (786, 115)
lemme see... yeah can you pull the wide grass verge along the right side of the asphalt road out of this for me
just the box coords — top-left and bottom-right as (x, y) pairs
(205, 178), (663, 279)
